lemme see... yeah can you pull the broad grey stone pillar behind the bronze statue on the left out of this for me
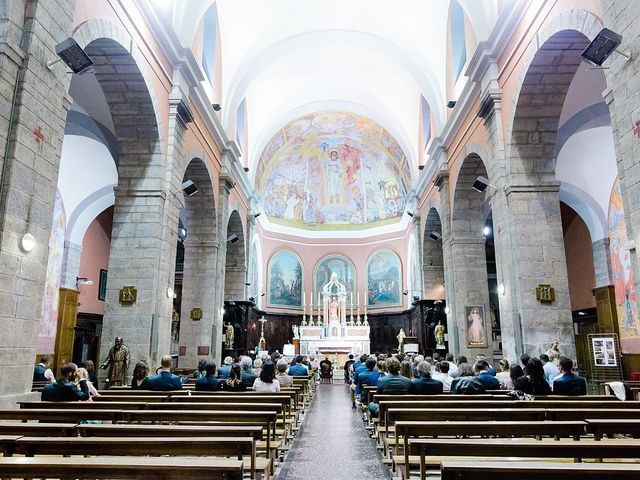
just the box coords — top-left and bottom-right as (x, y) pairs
(100, 94), (190, 375)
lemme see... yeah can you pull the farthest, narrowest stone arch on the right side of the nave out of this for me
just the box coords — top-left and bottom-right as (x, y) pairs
(422, 206), (446, 300)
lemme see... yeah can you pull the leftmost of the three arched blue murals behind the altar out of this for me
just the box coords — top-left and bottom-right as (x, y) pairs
(267, 250), (302, 308)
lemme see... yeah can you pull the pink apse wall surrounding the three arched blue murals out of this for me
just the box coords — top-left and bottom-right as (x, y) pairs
(257, 225), (411, 312)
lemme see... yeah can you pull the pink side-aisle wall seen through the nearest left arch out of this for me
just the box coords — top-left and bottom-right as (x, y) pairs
(78, 207), (113, 315)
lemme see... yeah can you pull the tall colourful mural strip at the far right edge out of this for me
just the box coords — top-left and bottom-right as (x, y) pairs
(609, 179), (640, 353)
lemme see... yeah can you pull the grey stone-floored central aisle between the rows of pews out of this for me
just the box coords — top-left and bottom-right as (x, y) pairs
(278, 384), (390, 480)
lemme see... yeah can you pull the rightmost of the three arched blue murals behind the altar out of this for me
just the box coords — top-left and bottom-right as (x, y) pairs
(367, 250), (402, 308)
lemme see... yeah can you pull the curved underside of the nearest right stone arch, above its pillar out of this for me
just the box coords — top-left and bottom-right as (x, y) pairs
(505, 10), (602, 183)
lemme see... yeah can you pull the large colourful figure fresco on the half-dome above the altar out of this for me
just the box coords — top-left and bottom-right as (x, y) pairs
(256, 110), (410, 230)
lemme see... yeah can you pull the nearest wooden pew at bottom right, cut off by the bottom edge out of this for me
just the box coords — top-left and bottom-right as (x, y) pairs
(441, 460), (640, 480)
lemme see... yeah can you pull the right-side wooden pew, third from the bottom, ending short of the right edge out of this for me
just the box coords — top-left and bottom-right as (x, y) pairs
(395, 418), (586, 478)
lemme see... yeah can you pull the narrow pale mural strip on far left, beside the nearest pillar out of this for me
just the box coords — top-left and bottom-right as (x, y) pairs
(36, 191), (66, 353)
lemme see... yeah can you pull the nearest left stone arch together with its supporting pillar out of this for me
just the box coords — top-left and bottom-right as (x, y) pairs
(74, 19), (170, 374)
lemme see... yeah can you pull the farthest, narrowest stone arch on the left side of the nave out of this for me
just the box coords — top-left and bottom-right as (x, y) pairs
(224, 210), (247, 300)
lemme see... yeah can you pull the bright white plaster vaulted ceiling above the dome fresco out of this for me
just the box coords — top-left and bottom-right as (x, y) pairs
(165, 0), (497, 172)
